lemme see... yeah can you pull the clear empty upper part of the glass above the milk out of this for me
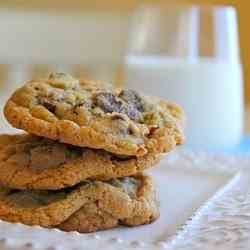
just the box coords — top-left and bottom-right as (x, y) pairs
(129, 3), (241, 61)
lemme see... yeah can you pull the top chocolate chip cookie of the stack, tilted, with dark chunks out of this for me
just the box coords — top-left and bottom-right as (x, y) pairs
(4, 73), (184, 156)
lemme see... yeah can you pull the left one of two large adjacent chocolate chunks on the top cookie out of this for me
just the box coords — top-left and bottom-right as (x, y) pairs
(96, 93), (124, 113)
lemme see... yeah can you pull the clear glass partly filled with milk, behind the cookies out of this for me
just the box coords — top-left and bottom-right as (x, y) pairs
(124, 6), (244, 149)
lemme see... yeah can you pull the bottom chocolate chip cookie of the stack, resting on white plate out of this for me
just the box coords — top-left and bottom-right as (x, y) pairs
(0, 175), (159, 232)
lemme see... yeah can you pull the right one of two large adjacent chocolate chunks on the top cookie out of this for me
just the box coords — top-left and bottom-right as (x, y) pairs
(119, 89), (145, 112)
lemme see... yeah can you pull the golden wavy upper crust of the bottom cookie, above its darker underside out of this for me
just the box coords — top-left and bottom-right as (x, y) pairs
(0, 175), (158, 230)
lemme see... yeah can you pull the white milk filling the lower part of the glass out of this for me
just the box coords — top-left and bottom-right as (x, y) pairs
(125, 56), (243, 148)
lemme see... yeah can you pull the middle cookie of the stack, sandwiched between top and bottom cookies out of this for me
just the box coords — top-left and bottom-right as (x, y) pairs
(0, 134), (161, 190)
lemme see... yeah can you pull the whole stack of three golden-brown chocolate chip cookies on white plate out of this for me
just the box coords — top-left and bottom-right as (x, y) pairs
(0, 73), (183, 232)
